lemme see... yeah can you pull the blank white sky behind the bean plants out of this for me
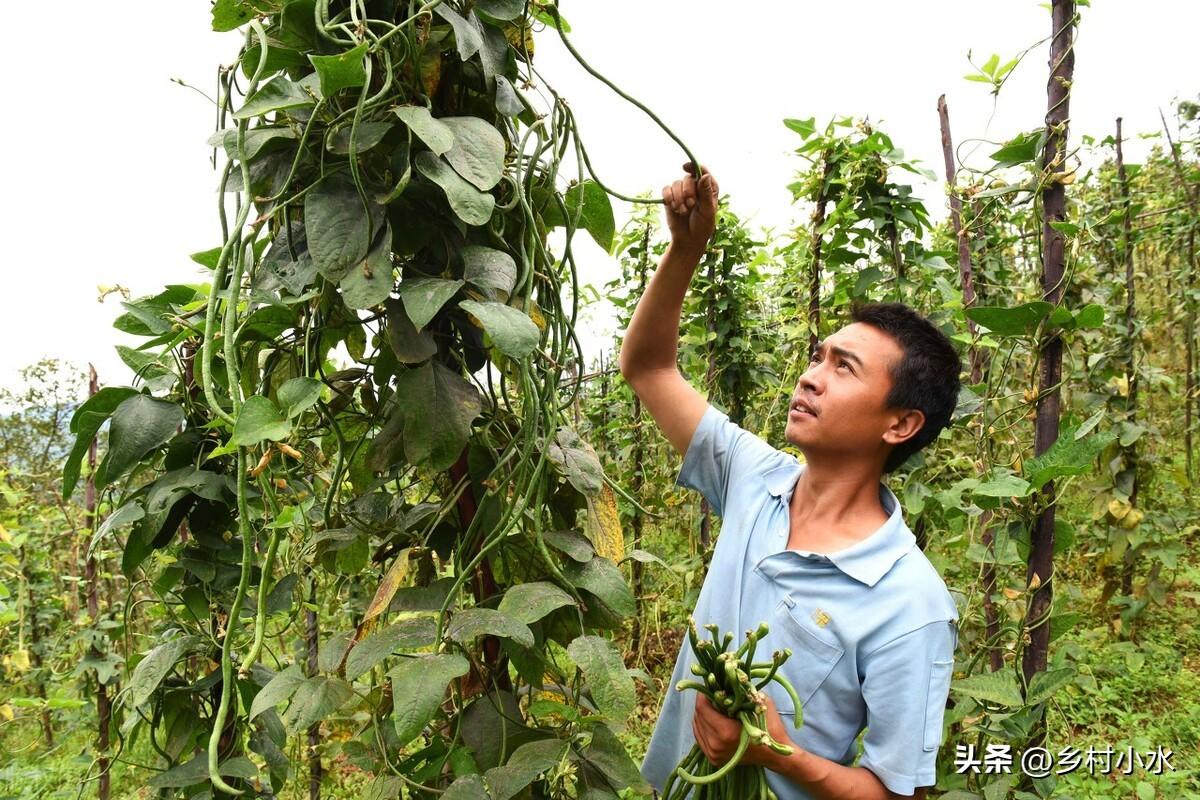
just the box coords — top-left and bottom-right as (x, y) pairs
(0, 0), (1200, 398)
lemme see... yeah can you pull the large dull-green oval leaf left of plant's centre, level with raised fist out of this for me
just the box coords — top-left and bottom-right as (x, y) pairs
(304, 178), (374, 283)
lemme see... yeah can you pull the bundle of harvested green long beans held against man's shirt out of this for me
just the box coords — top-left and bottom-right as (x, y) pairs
(662, 618), (802, 800)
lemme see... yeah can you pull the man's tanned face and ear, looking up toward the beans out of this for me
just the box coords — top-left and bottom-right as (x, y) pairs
(784, 323), (924, 459)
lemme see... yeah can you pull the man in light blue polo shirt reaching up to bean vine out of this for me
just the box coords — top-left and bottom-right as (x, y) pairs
(620, 164), (961, 800)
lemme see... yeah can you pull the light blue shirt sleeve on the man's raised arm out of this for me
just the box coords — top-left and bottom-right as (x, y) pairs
(676, 403), (780, 517)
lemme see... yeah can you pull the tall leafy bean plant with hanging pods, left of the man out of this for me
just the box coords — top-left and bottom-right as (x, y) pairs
(62, 0), (696, 799)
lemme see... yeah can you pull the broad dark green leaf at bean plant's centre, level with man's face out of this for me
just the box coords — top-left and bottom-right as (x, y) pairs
(396, 362), (482, 471)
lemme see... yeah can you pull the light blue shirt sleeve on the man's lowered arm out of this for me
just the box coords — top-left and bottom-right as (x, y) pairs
(859, 620), (958, 794)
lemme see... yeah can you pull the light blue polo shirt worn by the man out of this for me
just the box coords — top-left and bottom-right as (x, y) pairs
(641, 404), (959, 800)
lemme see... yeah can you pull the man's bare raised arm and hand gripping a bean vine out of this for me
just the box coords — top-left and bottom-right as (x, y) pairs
(618, 163), (719, 453)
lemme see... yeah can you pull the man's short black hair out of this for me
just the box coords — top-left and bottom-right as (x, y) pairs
(851, 302), (962, 473)
